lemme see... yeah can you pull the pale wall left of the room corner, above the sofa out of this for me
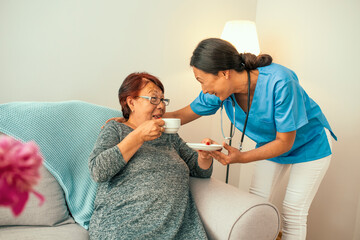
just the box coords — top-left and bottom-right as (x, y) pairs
(0, 0), (256, 184)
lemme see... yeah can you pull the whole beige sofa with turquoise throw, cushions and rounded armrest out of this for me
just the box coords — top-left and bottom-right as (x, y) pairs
(0, 101), (280, 240)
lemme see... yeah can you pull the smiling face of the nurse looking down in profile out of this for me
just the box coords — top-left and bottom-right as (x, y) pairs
(193, 67), (231, 101)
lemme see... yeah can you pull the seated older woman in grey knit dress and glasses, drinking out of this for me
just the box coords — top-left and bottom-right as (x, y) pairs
(89, 73), (212, 239)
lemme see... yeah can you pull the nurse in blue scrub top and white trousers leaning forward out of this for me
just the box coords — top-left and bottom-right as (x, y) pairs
(164, 38), (336, 240)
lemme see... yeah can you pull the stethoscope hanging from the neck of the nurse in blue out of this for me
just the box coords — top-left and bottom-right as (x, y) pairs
(220, 71), (250, 151)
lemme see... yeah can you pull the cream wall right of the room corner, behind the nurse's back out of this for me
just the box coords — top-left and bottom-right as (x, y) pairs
(256, 0), (360, 240)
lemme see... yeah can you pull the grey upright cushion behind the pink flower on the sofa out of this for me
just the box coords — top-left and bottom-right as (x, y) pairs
(0, 133), (74, 226)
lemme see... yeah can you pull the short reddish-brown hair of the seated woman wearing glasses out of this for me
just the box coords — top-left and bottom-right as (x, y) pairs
(118, 72), (164, 120)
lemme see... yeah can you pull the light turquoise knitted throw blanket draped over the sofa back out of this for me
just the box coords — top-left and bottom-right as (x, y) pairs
(0, 101), (122, 229)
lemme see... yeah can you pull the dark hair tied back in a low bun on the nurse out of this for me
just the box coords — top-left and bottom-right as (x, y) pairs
(190, 38), (272, 75)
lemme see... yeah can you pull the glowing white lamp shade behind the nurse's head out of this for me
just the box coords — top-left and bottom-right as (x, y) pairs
(221, 20), (260, 55)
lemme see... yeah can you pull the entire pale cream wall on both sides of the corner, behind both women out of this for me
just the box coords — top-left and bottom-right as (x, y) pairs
(5, 0), (360, 240)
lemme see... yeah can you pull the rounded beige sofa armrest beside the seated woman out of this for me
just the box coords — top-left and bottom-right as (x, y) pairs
(190, 177), (280, 240)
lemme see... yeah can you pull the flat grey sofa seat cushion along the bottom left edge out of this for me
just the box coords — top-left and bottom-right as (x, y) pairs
(0, 223), (89, 240)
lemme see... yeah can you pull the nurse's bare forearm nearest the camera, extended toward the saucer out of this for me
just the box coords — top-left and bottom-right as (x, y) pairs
(239, 131), (296, 163)
